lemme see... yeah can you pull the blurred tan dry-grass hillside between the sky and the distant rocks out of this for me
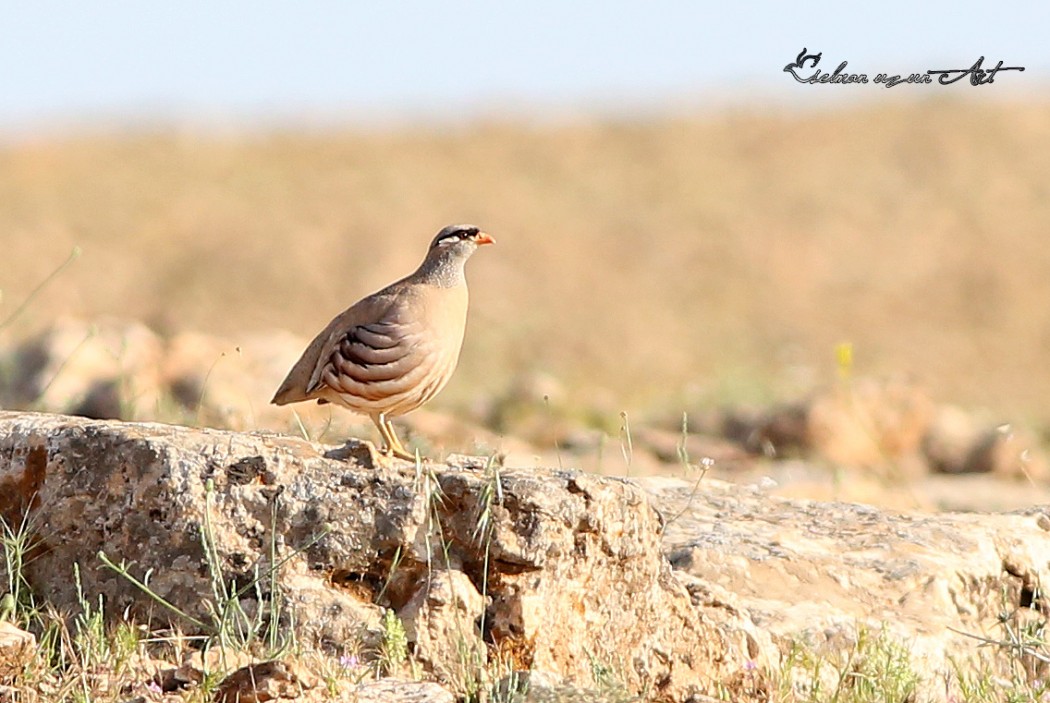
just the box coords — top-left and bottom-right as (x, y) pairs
(0, 102), (1050, 424)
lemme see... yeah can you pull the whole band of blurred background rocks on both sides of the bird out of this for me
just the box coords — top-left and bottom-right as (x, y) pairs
(0, 318), (1050, 493)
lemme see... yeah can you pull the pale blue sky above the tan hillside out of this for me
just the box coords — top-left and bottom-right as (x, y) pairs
(0, 0), (1050, 132)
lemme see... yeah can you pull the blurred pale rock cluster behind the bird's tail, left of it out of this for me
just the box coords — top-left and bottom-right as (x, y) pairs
(0, 318), (371, 438)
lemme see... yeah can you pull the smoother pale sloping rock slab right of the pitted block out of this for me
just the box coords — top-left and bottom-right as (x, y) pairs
(638, 477), (1050, 700)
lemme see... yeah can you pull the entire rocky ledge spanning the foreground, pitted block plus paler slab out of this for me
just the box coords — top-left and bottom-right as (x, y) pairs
(0, 412), (1050, 702)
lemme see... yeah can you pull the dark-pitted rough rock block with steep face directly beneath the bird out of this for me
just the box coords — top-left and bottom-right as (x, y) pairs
(0, 412), (765, 701)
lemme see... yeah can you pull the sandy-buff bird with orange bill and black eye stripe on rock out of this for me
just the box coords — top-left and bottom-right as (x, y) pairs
(270, 225), (496, 461)
